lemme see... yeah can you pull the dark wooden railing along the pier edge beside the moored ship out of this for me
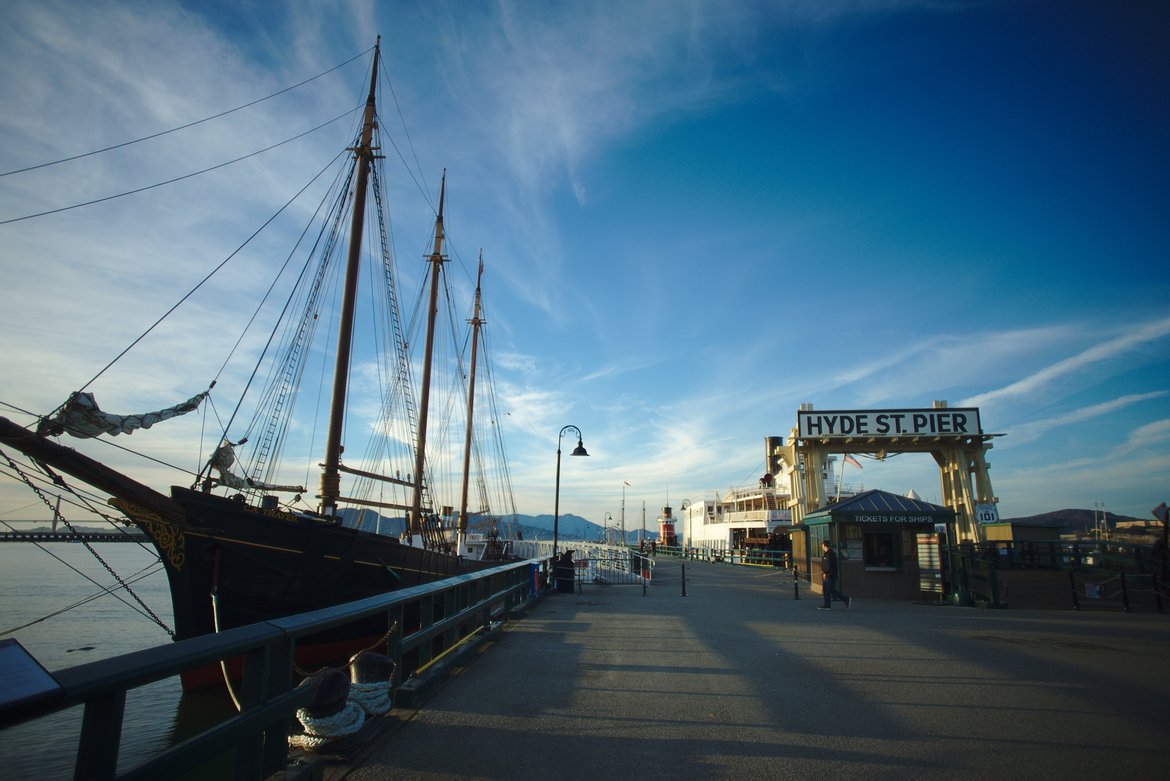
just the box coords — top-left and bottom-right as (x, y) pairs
(0, 561), (543, 781)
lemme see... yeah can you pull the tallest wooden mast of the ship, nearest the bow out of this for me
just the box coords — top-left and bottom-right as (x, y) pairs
(321, 35), (381, 516)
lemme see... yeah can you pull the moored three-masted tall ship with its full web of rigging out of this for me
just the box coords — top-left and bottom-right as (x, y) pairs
(0, 43), (515, 689)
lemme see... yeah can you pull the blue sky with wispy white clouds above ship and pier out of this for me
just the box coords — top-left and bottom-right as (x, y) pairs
(0, 0), (1170, 525)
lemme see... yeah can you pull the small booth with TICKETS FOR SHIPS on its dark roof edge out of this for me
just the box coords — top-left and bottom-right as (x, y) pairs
(792, 490), (955, 600)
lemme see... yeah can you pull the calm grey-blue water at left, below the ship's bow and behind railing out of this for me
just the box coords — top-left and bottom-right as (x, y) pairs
(0, 542), (232, 779)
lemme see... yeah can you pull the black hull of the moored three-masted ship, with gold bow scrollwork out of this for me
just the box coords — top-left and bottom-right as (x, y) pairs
(136, 486), (498, 690)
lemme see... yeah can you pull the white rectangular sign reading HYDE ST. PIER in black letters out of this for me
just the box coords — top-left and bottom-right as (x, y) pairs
(797, 407), (983, 440)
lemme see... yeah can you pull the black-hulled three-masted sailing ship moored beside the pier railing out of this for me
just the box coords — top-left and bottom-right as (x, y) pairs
(0, 41), (510, 689)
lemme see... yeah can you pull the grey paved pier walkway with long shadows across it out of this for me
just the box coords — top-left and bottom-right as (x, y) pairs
(325, 559), (1170, 781)
